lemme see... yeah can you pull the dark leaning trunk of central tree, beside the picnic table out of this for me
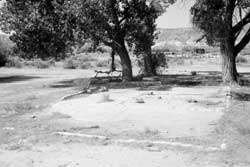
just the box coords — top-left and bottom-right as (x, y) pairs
(115, 42), (133, 81)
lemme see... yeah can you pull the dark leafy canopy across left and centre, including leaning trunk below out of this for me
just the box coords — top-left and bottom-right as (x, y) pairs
(0, 0), (175, 79)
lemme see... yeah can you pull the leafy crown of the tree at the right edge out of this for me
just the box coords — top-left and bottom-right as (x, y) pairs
(191, 0), (250, 53)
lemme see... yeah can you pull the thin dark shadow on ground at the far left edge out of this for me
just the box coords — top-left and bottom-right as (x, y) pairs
(0, 75), (40, 84)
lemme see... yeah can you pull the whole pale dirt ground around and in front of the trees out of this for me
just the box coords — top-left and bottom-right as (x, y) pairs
(0, 60), (250, 167)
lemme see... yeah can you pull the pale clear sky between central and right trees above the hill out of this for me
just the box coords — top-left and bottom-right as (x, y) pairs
(157, 0), (194, 28)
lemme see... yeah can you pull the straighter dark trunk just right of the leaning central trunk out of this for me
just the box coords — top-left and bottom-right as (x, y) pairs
(143, 47), (156, 76)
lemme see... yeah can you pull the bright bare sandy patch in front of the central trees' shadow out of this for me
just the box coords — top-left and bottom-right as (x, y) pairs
(51, 87), (224, 137)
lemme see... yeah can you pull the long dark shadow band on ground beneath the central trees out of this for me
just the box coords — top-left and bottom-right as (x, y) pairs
(50, 71), (250, 91)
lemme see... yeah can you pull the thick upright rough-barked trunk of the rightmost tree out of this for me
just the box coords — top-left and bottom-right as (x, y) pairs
(221, 41), (238, 84)
